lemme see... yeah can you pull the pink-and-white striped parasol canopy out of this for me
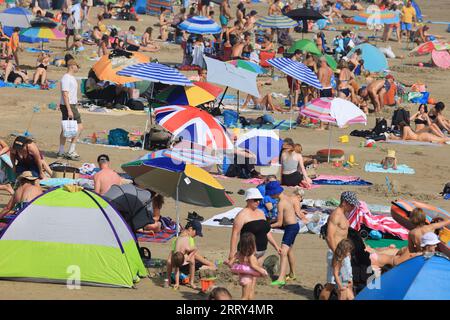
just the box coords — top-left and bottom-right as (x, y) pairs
(300, 98), (367, 127)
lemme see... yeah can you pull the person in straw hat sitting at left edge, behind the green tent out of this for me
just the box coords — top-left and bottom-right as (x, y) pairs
(0, 171), (42, 218)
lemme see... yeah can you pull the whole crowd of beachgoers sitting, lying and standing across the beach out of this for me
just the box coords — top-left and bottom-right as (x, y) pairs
(0, 0), (450, 300)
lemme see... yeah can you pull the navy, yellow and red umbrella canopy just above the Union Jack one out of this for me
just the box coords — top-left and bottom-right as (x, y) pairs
(156, 81), (223, 107)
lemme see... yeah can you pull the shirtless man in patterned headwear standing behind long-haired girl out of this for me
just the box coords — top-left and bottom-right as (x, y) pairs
(319, 191), (359, 300)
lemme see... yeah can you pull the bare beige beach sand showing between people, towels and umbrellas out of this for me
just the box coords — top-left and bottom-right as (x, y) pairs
(0, 0), (450, 300)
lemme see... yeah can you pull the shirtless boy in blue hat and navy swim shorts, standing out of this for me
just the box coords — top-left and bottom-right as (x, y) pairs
(266, 181), (304, 286)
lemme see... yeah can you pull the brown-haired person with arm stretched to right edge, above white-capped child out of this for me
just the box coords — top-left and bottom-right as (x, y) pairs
(408, 208), (450, 252)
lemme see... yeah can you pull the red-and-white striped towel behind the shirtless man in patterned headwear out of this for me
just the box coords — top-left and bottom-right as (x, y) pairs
(347, 201), (409, 240)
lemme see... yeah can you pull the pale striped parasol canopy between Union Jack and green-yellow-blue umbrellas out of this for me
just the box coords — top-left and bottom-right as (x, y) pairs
(139, 148), (220, 168)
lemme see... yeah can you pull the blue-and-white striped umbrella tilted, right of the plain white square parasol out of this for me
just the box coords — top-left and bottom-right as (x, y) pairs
(267, 58), (322, 89)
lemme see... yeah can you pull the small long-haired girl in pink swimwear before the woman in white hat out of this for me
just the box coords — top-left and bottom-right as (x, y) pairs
(232, 232), (268, 300)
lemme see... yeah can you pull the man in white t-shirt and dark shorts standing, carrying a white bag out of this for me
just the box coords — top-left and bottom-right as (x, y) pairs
(57, 59), (83, 160)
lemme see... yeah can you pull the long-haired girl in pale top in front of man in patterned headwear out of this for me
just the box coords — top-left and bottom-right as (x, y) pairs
(331, 239), (355, 300)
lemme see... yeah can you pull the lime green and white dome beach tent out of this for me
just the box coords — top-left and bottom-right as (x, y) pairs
(0, 187), (147, 288)
